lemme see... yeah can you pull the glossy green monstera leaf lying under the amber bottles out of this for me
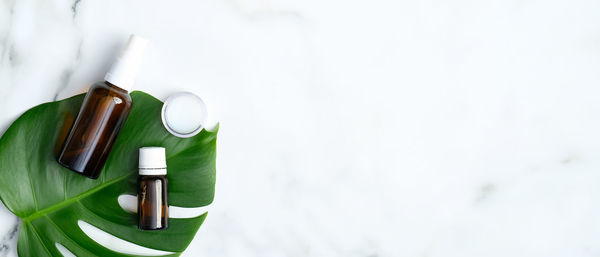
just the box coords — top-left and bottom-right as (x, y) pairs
(0, 91), (217, 257)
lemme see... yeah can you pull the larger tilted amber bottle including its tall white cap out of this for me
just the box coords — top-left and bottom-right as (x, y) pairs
(58, 35), (147, 179)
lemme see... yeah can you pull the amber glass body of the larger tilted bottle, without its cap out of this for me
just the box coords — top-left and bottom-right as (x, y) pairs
(58, 82), (132, 179)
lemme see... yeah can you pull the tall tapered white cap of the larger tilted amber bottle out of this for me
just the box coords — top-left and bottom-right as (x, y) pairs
(104, 34), (148, 91)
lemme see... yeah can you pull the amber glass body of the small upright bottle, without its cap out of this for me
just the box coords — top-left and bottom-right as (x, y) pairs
(138, 175), (169, 230)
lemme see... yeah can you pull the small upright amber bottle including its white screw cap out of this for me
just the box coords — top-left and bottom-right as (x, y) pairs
(138, 147), (169, 230)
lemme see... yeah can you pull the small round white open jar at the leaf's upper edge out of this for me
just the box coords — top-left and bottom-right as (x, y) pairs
(161, 92), (207, 138)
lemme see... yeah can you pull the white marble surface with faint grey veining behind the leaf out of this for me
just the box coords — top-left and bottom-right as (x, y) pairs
(0, 0), (600, 257)
